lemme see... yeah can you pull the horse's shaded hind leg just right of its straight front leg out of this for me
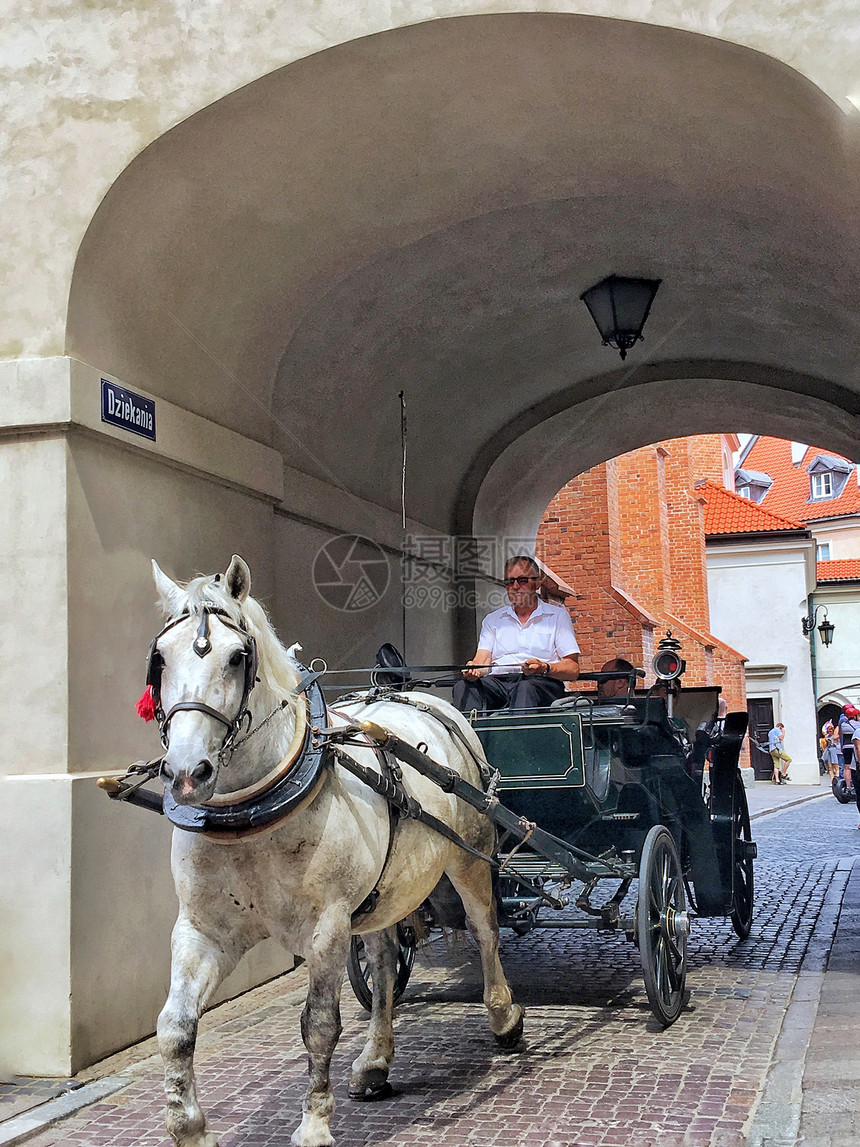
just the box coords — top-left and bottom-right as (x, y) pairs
(350, 926), (399, 1099)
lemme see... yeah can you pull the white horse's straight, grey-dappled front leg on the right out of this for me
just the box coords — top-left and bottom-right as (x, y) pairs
(291, 910), (350, 1147)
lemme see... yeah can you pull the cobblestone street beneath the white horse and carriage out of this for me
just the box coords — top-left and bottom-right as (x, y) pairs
(6, 798), (860, 1147)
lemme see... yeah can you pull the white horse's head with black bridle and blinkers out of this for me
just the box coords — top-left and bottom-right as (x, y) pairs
(147, 554), (257, 805)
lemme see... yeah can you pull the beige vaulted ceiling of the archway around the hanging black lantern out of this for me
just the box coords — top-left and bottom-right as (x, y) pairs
(68, 15), (860, 541)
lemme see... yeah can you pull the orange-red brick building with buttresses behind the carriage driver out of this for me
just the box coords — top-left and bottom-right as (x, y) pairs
(538, 435), (746, 710)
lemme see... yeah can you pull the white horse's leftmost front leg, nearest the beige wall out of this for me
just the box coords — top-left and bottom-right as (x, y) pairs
(158, 916), (237, 1147)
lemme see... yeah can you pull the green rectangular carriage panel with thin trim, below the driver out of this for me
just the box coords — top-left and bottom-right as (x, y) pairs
(472, 710), (585, 789)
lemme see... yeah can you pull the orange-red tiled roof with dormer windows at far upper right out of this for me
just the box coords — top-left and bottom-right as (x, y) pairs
(741, 435), (860, 522)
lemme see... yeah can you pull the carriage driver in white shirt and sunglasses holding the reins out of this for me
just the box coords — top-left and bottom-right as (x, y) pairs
(454, 555), (579, 712)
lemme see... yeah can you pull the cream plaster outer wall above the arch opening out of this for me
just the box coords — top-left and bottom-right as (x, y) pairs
(0, 0), (860, 359)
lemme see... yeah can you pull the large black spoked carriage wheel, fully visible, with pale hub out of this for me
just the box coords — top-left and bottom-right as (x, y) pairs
(636, 825), (690, 1028)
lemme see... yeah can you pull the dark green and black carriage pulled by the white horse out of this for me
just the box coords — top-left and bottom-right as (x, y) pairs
(349, 640), (756, 1025)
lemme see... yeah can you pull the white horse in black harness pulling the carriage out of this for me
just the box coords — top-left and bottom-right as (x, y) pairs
(150, 555), (523, 1147)
